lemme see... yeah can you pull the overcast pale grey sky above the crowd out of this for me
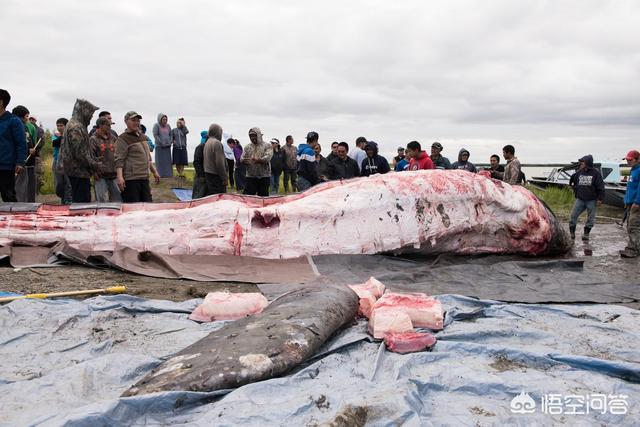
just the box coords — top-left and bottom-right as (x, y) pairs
(0, 0), (640, 163)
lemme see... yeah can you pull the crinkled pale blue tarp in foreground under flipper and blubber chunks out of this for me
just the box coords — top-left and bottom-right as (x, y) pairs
(0, 295), (640, 427)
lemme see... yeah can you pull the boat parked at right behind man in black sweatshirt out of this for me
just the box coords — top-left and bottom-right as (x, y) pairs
(528, 162), (627, 208)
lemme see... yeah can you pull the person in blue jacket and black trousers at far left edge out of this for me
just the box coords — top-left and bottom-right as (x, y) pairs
(0, 89), (27, 202)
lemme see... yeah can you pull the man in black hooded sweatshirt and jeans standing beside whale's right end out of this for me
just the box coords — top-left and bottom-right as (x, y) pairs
(569, 154), (604, 242)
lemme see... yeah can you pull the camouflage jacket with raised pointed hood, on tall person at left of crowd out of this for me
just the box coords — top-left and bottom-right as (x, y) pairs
(60, 99), (101, 178)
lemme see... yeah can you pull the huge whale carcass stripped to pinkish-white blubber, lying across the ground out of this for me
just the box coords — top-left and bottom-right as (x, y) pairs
(0, 170), (570, 258)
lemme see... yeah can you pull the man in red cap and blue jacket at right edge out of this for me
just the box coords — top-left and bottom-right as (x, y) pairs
(620, 150), (640, 258)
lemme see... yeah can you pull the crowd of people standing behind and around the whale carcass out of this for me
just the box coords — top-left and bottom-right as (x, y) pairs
(0, 89), (640, 257)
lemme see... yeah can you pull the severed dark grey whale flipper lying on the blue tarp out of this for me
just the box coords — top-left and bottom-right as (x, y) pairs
(122, 284), (358, 397)
